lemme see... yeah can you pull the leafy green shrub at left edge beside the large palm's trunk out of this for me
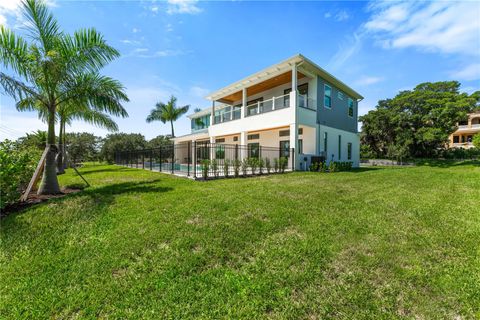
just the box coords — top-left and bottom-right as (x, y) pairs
(0, 140), (41, 209)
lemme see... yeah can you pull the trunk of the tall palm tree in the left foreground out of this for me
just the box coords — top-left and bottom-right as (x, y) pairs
(37, 107), (60, 194)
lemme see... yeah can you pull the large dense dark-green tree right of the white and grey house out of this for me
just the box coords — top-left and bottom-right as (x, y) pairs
(359, 81), (480, 158)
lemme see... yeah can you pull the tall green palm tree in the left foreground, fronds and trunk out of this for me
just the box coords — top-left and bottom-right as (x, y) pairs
(0, 0), (128, 194)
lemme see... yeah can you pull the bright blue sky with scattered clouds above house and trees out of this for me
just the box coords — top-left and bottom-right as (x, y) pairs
(0, 0), (480, 139)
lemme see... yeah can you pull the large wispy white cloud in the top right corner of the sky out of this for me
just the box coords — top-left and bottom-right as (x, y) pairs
(364, 1), (480, 56)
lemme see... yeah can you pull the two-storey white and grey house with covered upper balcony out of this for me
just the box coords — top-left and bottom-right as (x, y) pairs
(173, 54), (363, 170)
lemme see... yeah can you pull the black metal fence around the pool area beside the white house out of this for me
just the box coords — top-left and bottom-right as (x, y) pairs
(115, 142), (295, 179)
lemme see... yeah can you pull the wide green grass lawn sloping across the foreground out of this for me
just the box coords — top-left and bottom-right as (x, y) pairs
(0, 164), (480, 319)
